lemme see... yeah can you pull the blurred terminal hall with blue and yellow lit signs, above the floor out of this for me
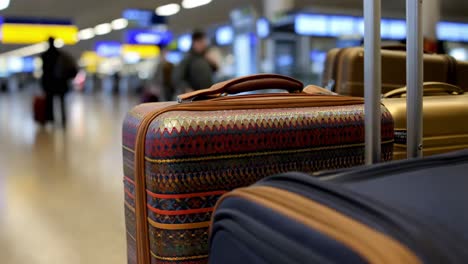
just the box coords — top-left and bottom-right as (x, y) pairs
(0, 0), (468, 94)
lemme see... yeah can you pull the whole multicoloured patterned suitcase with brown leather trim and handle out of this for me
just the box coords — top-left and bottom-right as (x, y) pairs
(123, 74), (393, 264)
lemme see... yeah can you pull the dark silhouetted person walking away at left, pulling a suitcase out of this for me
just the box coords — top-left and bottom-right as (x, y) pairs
(41, 37), (78, 127)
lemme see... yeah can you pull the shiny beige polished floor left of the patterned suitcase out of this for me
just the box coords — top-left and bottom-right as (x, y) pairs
(0, 89), (136, 264)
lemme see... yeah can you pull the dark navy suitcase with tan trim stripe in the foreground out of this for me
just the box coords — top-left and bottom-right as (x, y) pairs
(209, 151), (468, 264)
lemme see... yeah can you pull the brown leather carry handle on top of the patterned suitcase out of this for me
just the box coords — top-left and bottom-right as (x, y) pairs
(177, 74), (303, 102)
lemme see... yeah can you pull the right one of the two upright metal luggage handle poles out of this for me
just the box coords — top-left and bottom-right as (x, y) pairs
(406, 0), (424, 158)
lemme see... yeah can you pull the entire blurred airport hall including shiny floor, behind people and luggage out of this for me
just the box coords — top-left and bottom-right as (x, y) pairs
(0, 0), (468, 264)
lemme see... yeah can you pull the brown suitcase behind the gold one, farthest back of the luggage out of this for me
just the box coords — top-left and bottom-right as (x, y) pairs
(322, 46), (468, 96)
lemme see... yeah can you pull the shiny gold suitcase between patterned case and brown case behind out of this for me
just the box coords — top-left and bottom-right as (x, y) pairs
(382, 83), (468, 159)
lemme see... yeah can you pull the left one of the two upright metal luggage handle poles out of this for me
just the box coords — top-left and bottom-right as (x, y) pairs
(364, 0), (382, 165)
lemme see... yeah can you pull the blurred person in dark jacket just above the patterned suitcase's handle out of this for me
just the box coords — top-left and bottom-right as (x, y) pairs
(173, 30), (219, 94)
